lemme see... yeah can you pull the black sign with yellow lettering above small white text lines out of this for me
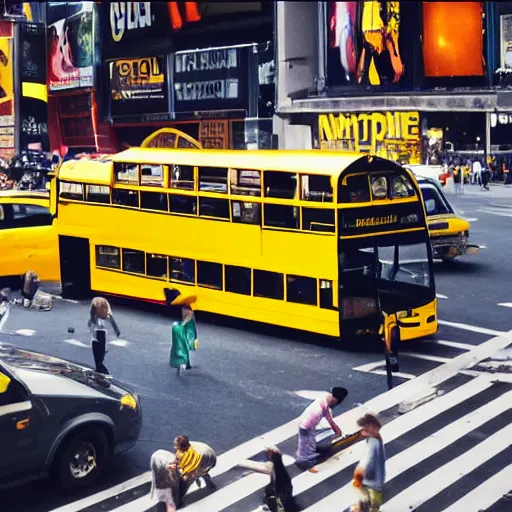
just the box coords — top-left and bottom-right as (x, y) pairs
(108, 57), (169, 117)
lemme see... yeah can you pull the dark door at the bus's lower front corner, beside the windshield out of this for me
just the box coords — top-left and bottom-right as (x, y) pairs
(339, 243), (381, 341)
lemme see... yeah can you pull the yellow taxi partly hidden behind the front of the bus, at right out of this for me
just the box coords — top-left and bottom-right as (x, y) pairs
(416, 177), (480, 261)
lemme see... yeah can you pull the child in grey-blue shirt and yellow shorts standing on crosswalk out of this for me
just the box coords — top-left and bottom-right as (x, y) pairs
(345, 413), (386, 512)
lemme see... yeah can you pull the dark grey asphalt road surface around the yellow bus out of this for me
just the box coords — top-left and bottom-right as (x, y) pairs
(0, 186), (512, 512)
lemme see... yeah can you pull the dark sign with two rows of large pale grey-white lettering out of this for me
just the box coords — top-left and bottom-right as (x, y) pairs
(174, 46), (257, 112)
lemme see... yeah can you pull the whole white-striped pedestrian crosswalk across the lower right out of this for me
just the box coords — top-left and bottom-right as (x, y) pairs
(54, 326), (512, 512)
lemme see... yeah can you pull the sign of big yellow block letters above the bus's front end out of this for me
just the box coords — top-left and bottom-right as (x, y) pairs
(318, 112), (420, 153)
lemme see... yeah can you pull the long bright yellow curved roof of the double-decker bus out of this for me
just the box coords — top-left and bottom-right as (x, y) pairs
(112, 148), (366, 175)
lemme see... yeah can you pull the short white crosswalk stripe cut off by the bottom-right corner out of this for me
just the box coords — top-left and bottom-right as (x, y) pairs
(443, 464), (512, 512)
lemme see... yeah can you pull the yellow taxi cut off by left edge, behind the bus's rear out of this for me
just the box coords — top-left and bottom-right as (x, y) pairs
(0, 190), (60, 286)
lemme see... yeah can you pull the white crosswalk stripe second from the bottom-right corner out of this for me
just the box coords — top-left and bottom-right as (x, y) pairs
(386, 422), (512, 512)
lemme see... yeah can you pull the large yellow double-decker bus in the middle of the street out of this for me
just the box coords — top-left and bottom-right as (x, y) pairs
(52, 148), (437, 339)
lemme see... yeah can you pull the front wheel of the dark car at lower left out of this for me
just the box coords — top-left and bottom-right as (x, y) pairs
(57, 428), (109, 490)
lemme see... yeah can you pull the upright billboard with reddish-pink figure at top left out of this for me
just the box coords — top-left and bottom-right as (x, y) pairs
(48, 2), (97, 92)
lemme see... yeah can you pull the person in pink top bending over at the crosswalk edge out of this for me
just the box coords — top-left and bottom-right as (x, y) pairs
(295, 387), (348, 467)
